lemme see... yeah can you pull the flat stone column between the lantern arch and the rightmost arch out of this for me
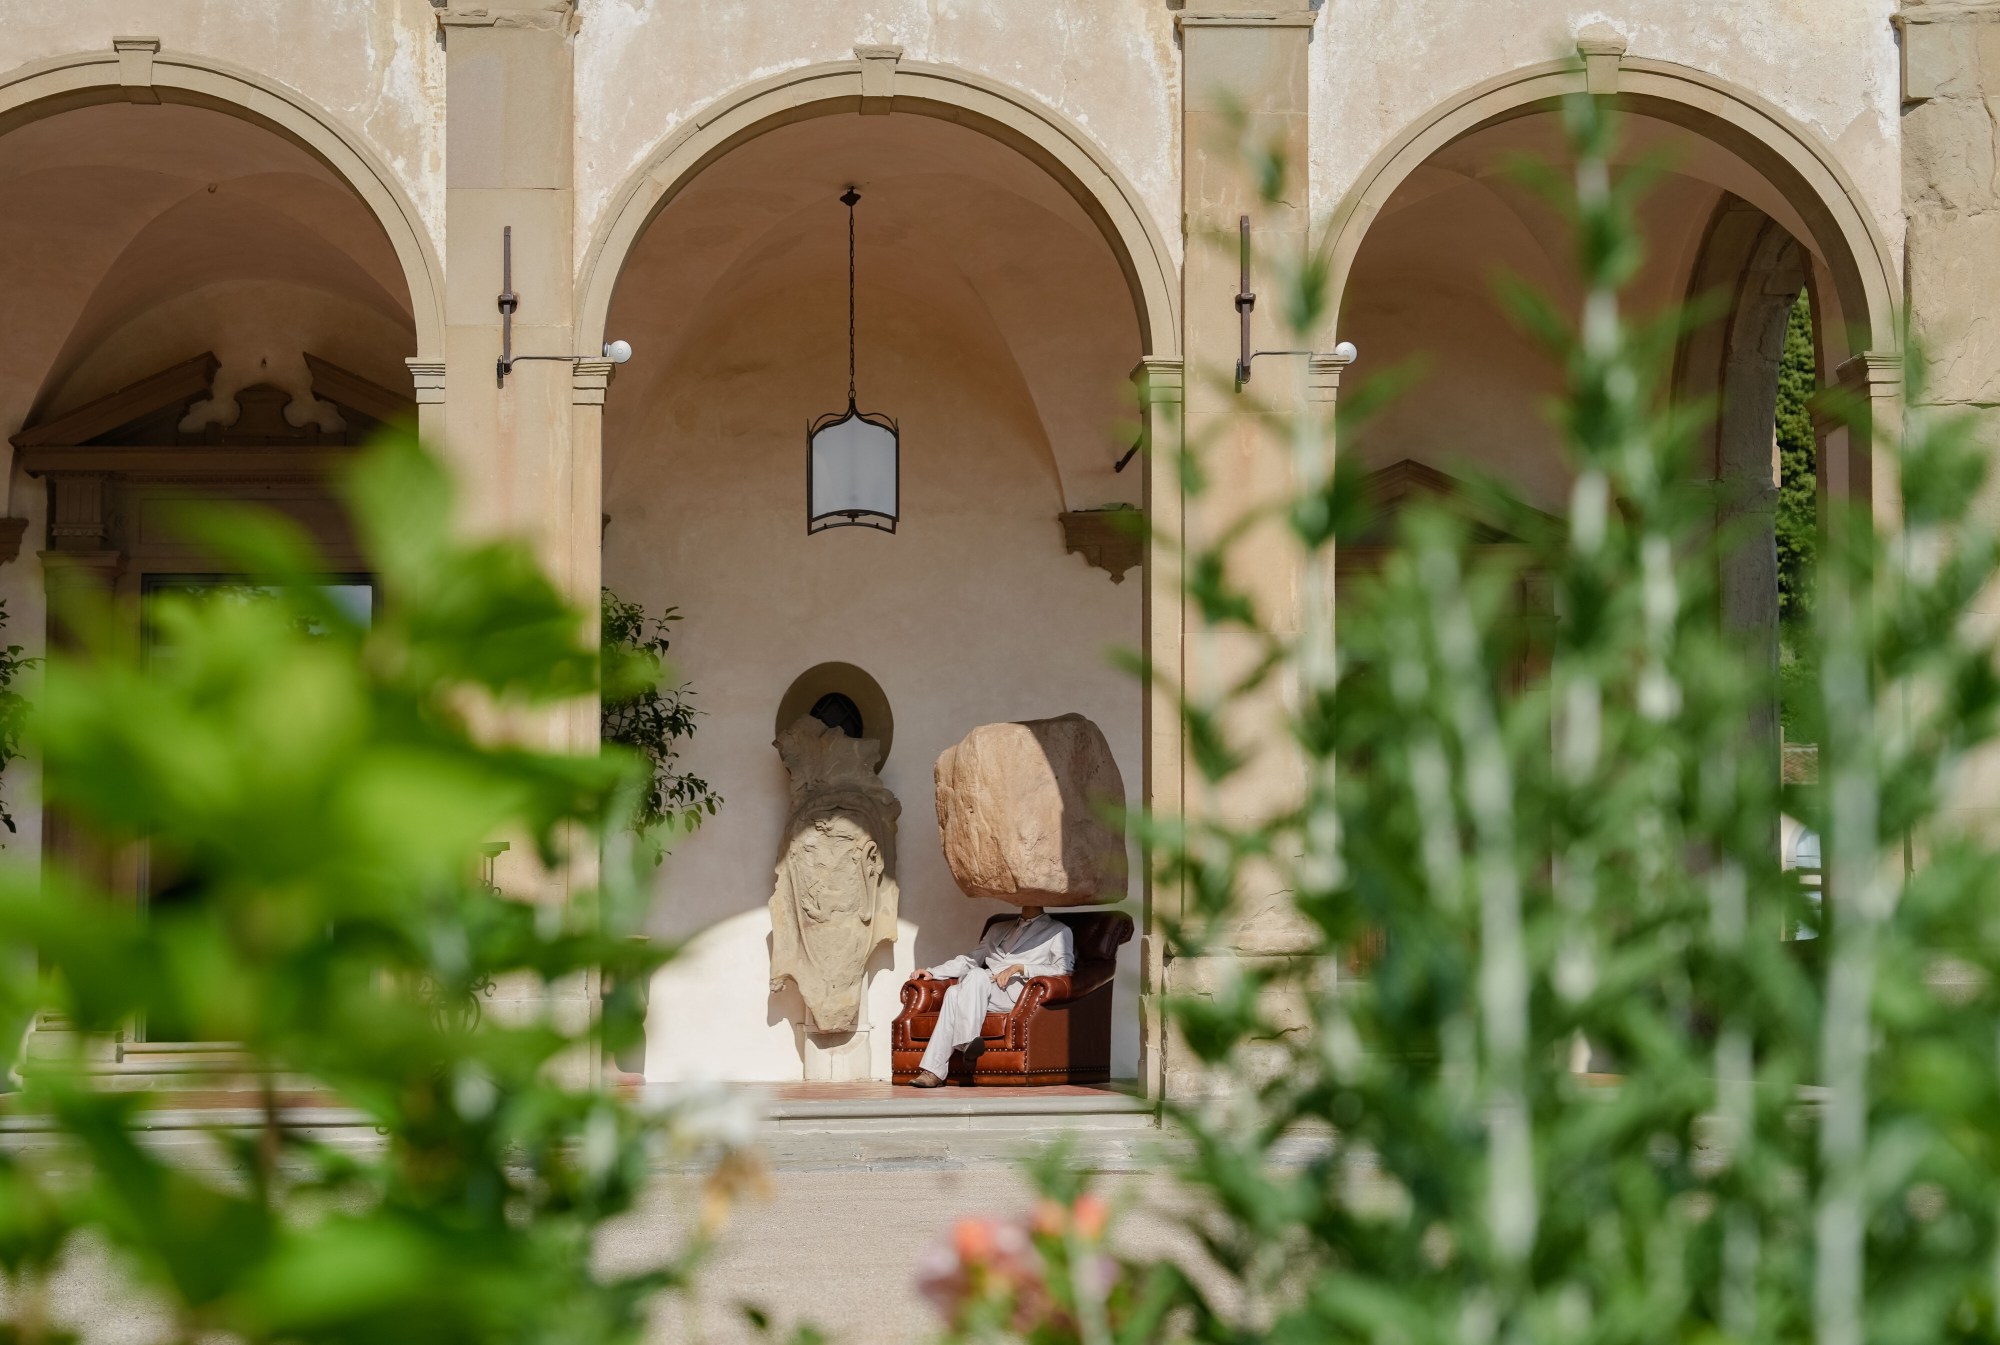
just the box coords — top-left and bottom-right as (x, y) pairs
(1154, 0), (1314, 1095)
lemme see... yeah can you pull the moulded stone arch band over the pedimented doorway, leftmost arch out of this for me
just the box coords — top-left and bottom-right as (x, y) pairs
(0, 38), (444, 360)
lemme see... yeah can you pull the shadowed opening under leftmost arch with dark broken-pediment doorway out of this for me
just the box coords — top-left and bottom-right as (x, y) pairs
(0, 90), (428, 1048)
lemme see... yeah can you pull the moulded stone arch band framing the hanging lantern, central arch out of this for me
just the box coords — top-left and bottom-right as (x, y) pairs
(576, 60), (1180, 358)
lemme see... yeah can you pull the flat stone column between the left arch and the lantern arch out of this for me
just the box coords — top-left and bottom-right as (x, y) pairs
(440, 0), (602, 1079)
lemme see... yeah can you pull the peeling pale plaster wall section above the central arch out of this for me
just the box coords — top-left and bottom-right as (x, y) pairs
(576, 0), (1180, 274)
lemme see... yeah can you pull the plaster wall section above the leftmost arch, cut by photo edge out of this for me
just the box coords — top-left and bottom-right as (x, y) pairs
(0, 0), (444, 250)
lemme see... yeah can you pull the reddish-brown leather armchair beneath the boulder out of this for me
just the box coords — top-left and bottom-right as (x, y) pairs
(890, 911), (1132, 1087)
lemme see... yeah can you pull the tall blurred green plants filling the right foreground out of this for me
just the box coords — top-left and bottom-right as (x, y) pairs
(958, 96), (2000, 1345)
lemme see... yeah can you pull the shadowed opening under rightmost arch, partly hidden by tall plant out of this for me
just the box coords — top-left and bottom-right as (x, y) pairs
(1334, 79), (1894, 904)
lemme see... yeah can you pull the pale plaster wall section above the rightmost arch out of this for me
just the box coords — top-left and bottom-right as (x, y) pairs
(1312, 0), (1902, 268)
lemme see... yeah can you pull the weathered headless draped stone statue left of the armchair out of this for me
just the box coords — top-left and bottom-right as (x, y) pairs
(770, 715), (902, 1033)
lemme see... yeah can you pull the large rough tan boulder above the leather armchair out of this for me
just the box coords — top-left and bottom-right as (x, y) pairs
(936, 715), (1126, 907)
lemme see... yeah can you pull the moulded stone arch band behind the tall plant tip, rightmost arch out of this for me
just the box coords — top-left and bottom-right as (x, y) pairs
(1324, 52), (1902, 364)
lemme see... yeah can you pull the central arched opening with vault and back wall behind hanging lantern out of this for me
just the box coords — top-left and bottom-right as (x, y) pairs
(586, 110), (1148, 1081)
